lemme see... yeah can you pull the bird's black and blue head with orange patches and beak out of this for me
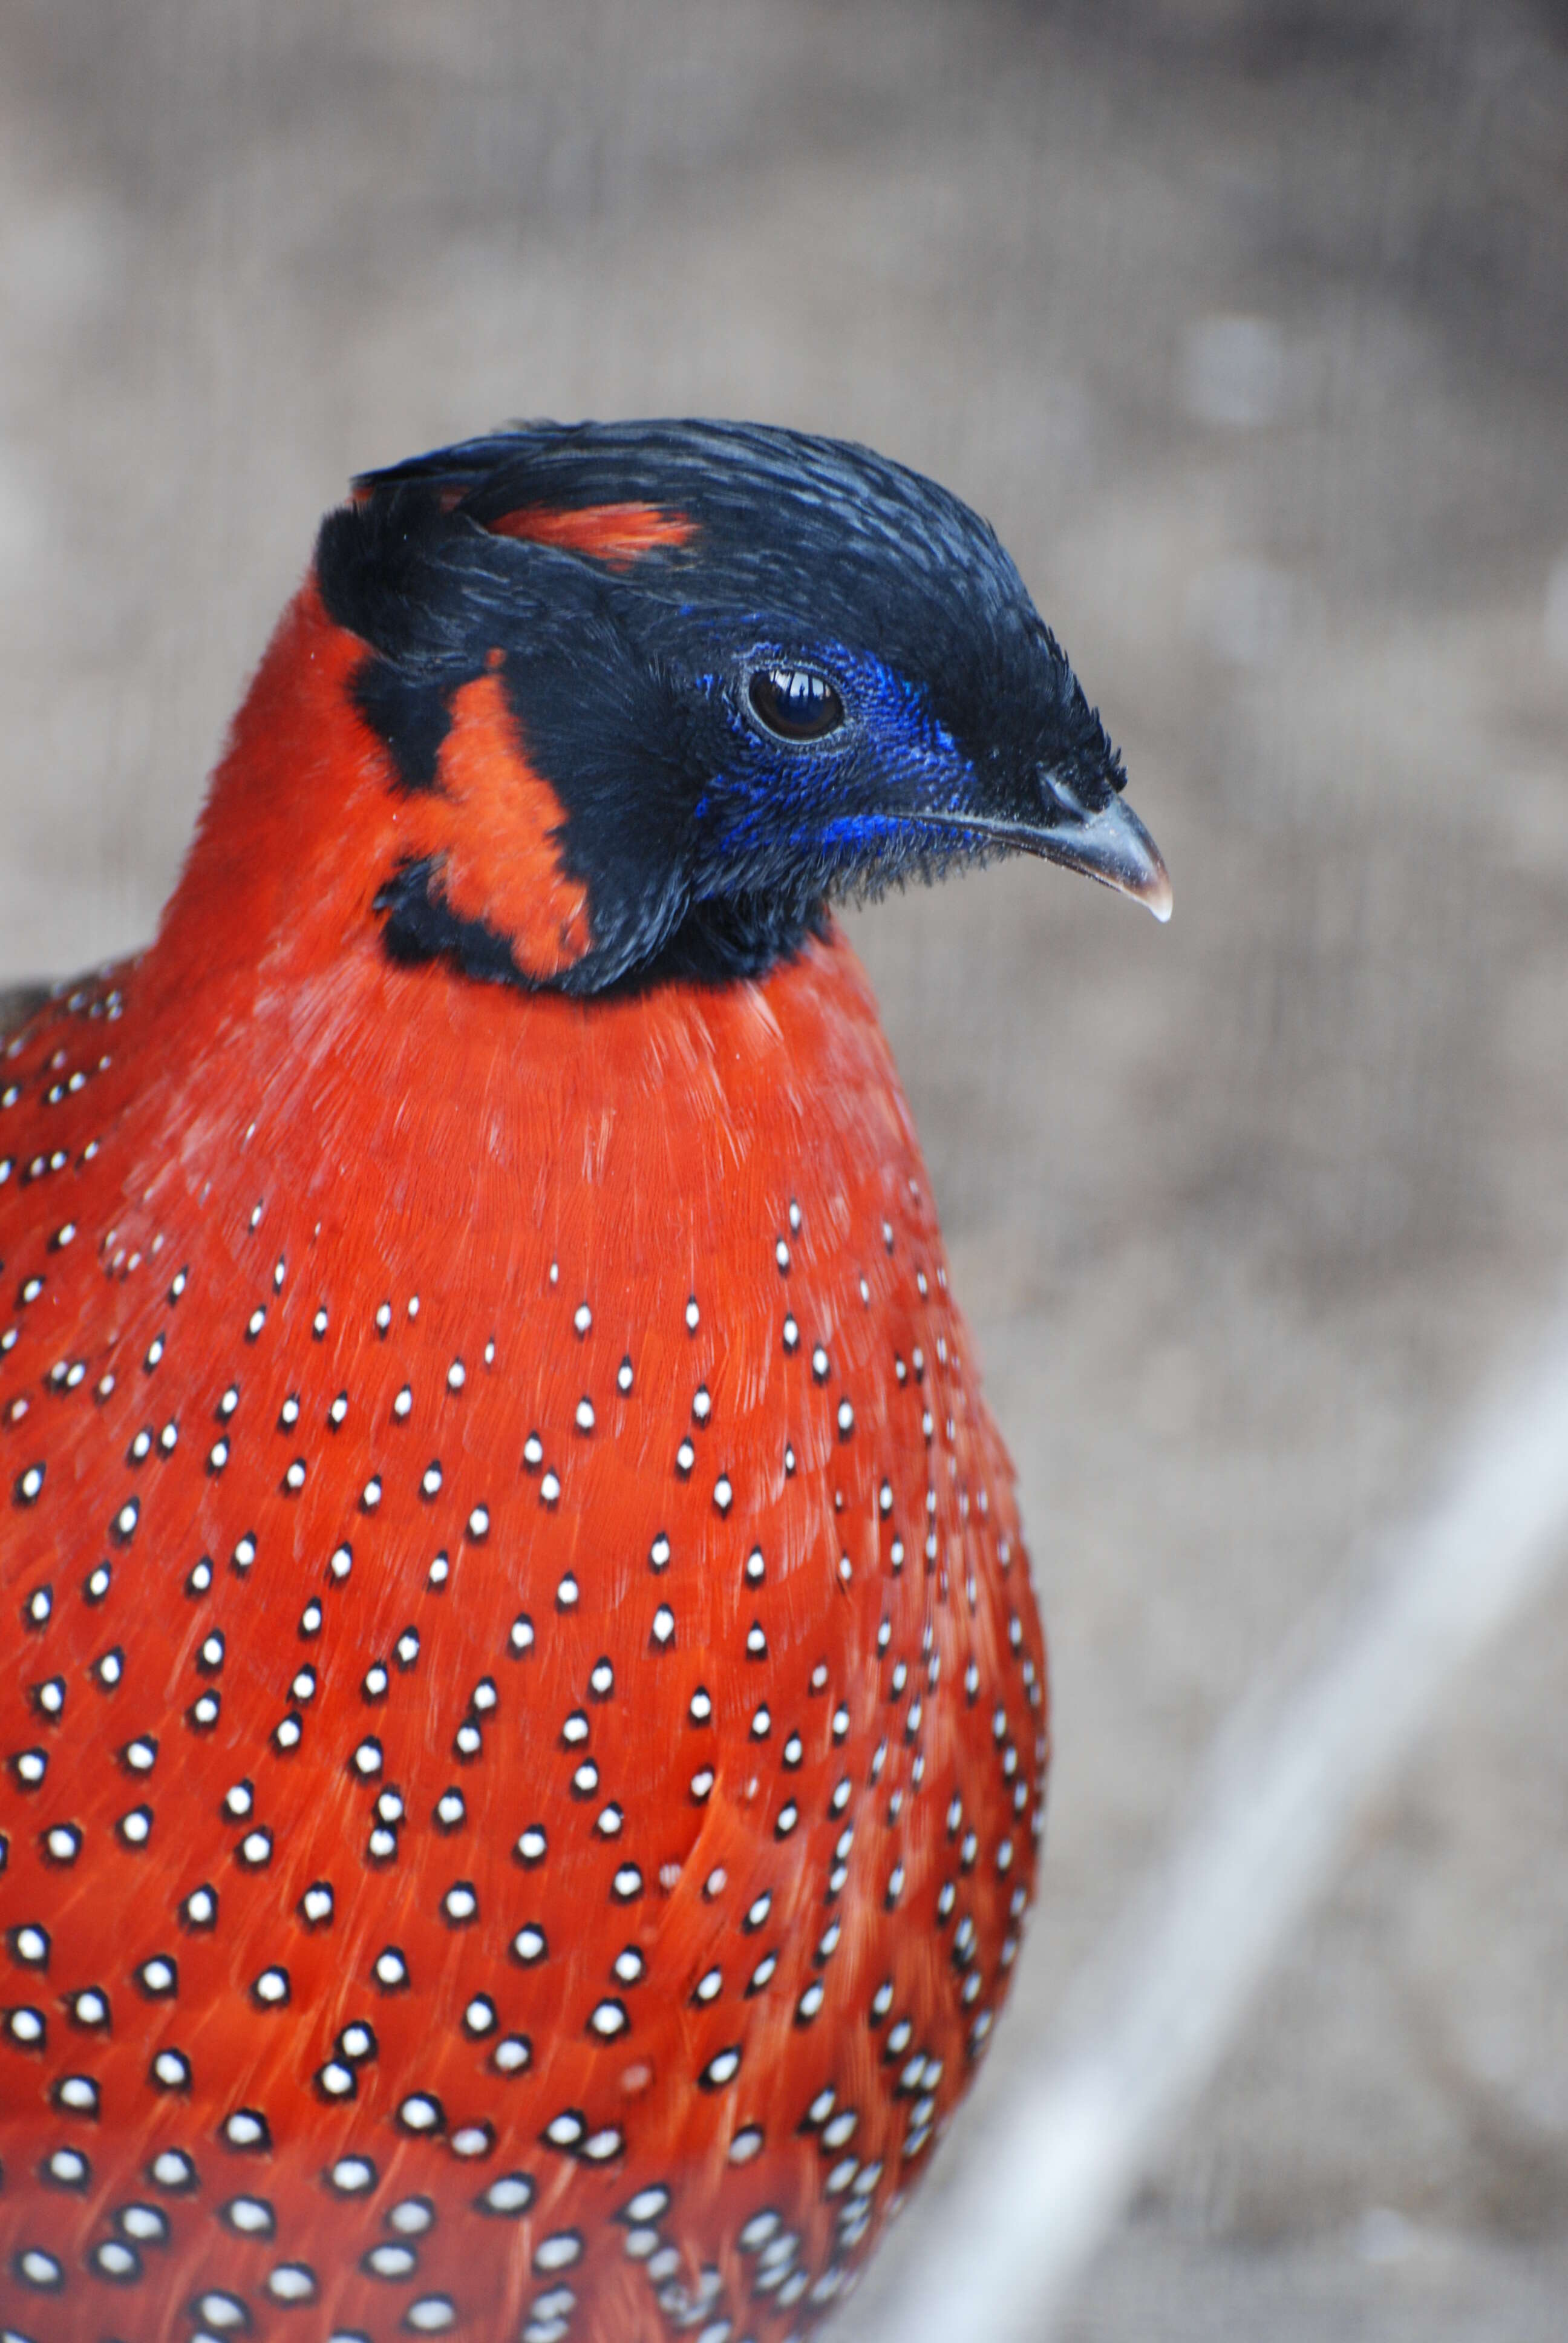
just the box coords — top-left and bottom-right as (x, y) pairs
(290, 422), (1169, 994)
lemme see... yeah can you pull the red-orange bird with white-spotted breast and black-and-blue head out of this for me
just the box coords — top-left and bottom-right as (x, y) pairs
(0, 419), (1169, 2343)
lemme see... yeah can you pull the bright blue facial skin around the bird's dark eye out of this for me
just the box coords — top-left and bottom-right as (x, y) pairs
(694, 640), (978, 888)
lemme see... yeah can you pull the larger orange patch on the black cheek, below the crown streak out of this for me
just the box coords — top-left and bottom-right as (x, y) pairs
(408, 666), (593, 979)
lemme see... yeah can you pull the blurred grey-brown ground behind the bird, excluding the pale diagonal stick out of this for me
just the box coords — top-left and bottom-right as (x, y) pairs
(0, 0), (1568, 2343)
